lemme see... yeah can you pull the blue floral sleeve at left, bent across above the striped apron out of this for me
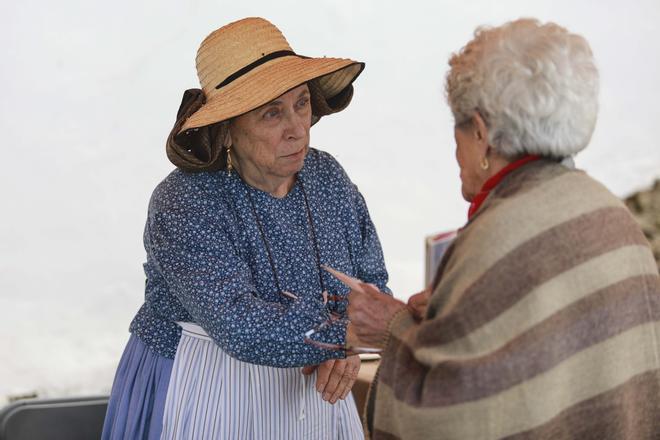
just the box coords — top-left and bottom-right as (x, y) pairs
(145, 186), (346, 367)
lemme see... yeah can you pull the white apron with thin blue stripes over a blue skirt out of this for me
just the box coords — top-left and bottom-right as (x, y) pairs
(161, 323), (364, 440)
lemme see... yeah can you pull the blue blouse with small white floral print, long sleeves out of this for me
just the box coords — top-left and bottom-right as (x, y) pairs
(130, 149), (389, 367)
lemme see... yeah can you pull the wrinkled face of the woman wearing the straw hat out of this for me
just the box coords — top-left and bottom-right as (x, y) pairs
(229, 84), (312, 181)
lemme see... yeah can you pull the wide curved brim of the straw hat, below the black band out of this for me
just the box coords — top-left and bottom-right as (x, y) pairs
(179, 56), (364, 133)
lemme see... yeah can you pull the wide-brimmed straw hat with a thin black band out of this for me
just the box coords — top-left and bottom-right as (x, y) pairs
(178, 17), (364, 133)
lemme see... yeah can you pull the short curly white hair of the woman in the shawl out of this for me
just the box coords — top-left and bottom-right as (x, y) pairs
(445, 19), (598, 158)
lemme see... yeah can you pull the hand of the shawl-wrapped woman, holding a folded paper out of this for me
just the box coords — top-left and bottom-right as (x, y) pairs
(346, 283), (406, 348)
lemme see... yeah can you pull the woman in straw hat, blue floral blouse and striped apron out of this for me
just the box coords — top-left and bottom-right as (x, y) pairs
(103, 18), (390, 439)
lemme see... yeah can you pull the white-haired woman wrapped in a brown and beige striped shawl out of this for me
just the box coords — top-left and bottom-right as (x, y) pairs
(340, 19), (660, 440)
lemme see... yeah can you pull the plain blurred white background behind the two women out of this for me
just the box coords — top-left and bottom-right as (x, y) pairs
(0, 0), (660, 404)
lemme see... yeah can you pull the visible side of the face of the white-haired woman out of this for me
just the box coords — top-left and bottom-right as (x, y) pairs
(454, 123), (487, 202)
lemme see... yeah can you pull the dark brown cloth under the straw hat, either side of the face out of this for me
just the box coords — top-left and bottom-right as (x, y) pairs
(166, 79), (353, 172)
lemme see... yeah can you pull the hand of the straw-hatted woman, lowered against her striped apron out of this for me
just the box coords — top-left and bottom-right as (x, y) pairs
(302, 355), (360, 404)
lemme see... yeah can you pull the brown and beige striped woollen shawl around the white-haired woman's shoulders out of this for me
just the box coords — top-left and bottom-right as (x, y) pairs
(369, 161), (660, 439)
